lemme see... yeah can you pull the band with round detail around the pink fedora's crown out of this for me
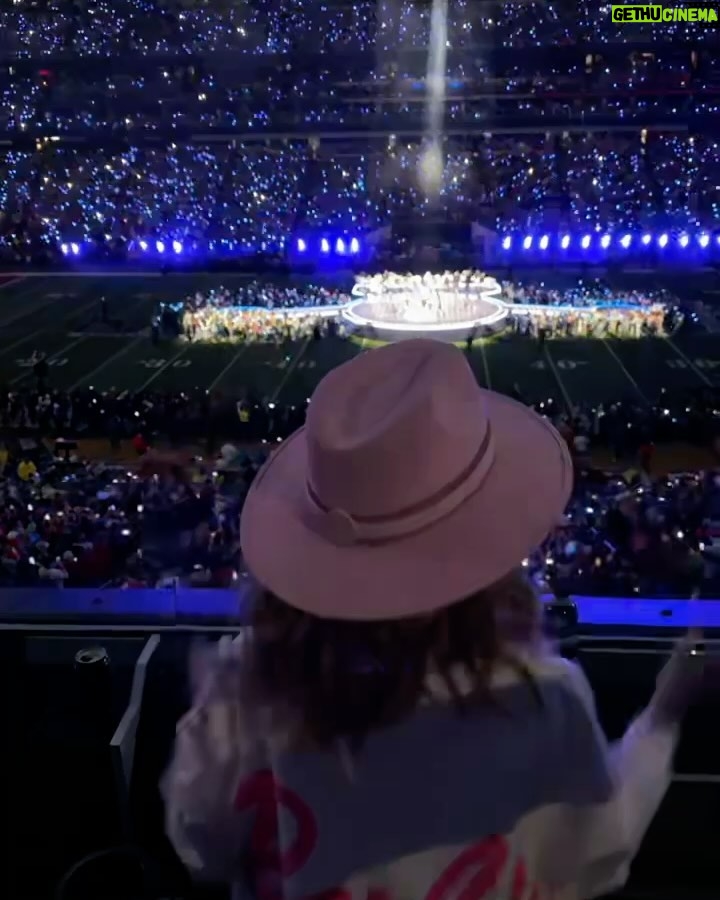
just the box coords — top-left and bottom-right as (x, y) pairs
(307, 423), (495, 547)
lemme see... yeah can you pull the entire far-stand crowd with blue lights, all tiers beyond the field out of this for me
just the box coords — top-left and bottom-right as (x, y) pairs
(0, 0), (720, 260)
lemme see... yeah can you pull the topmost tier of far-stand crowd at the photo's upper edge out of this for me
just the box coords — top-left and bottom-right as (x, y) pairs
(0, 0), (713, 56)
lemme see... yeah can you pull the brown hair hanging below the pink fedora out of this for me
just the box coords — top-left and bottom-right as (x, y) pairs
(245, 573), (541, 750)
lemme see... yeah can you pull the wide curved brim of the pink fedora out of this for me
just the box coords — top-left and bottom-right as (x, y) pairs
(241, 391), (573, 620)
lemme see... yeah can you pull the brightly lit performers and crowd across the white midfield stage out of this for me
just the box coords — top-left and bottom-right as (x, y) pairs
(176, 269), (682, 343)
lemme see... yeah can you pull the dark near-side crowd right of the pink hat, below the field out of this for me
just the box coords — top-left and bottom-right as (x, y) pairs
(524, 469), (720, 597)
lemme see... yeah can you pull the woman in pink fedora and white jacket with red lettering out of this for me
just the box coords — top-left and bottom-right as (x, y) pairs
(163, 340), (697, 900)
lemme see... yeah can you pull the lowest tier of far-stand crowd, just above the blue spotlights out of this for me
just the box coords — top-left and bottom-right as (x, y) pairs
(0, 132), (720, 258)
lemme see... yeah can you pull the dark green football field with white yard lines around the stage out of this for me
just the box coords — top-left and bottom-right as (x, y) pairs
(0, 275), (720, 404)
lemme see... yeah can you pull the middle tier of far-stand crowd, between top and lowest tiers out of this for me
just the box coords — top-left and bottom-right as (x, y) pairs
(0, 59), (720, 137)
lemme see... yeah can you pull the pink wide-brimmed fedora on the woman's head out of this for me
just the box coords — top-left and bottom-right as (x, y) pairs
(241, 340), (572, 620)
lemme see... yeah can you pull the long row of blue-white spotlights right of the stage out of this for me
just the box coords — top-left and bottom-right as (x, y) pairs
(500, 231), (720, 255)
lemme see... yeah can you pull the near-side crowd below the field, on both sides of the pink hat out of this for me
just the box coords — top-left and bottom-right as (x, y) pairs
(0, 394), (720, 597)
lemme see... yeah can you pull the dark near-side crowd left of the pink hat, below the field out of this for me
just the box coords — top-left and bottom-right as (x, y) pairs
(0, 444), (257, 587)
